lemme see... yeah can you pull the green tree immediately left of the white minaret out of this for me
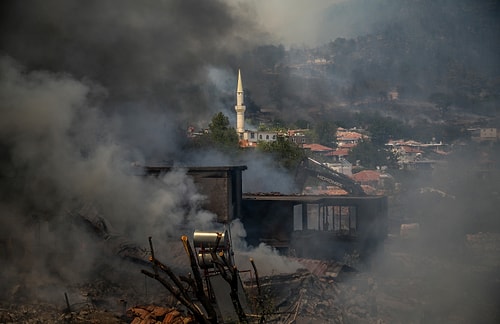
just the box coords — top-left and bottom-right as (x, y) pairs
(208, 112), (239, 150)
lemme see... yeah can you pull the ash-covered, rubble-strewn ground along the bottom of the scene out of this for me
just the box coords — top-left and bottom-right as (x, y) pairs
(0, 228), (500, 323)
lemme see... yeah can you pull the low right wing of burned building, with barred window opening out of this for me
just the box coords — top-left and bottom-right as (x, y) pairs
(242, 194), (387, 260)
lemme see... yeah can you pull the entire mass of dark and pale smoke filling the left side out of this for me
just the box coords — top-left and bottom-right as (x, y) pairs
(0, 1), (272, 294)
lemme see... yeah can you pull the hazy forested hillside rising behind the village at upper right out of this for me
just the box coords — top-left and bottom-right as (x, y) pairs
(238, 0), (500, 123)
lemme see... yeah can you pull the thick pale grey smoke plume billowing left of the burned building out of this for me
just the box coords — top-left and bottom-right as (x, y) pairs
(0, 57), (223, 302)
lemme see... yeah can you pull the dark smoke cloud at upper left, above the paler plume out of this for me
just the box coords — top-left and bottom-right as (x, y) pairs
(1, 0), (266, 118)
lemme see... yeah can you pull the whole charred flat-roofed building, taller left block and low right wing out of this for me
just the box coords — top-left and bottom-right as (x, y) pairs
(145, 166), (387, 259)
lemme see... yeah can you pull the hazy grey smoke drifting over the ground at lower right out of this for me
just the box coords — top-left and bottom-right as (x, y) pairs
(371, 145), (500, 323)
